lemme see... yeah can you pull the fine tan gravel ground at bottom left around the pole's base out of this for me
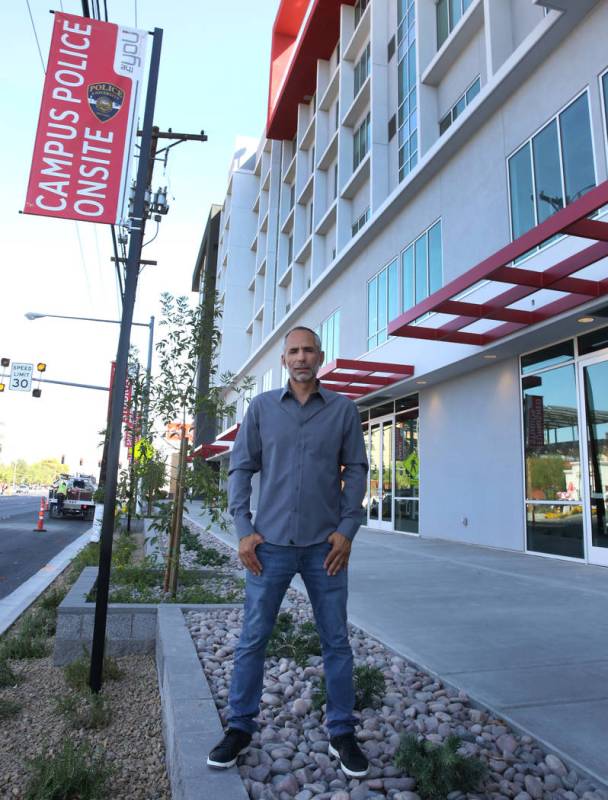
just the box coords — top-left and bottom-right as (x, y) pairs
(0, 656), (171, 800)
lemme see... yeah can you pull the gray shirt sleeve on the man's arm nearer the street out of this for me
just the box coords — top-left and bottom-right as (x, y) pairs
(228, 398), (262, 539)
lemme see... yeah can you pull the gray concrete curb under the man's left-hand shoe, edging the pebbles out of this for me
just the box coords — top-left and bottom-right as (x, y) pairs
(156, 605), (248, 800)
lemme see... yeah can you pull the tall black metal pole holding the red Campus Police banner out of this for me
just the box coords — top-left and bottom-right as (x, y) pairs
(89, 28), (163, 692)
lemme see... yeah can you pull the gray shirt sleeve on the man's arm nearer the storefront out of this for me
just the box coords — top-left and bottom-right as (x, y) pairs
(336, 403), (368, 541)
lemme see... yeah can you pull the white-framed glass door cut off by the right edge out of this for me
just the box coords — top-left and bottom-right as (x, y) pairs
(579, 355), (608, 566)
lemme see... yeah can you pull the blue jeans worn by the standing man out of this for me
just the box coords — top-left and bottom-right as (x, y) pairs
(228, 542), (356, 736)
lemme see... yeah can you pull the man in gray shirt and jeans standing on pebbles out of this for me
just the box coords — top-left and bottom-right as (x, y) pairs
(207, 327), (369, 778)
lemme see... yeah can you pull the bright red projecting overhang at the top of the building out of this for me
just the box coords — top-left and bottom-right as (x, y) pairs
(266, 0), (355, 139)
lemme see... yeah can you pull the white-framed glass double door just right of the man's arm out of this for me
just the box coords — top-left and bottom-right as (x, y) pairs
(367, 416), (394, 530)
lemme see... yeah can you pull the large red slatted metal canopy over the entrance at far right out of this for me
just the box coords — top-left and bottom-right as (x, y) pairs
(388, 181), (608, 345)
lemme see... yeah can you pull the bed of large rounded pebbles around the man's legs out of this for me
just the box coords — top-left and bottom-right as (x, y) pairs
(186, 584), (608, 800)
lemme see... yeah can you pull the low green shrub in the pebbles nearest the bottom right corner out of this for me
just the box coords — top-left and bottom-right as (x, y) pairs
(395, 734), (486, 800)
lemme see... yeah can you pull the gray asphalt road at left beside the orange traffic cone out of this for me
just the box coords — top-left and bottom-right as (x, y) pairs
(0, 495), (91, 598)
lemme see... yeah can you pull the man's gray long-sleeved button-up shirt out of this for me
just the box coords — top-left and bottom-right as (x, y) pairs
(228, 384), (367, 546)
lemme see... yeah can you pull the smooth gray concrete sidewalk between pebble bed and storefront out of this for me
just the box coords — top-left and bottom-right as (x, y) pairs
(184, 503), (608, 786)
